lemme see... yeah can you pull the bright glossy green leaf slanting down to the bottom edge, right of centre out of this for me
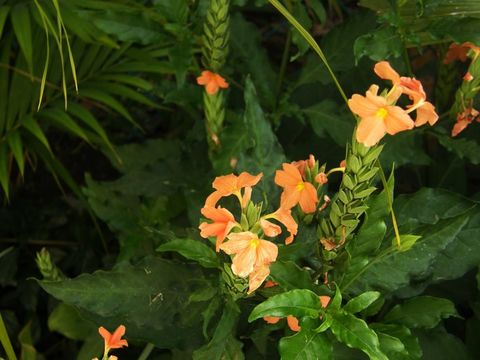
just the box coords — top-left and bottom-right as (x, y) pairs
(329, 310), (388, 360)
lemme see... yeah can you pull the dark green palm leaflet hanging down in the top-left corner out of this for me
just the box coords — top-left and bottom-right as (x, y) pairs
(11, 3), (33, 73)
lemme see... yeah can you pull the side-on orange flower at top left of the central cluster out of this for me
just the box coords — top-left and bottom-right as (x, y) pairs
(204, 172), (263, 207)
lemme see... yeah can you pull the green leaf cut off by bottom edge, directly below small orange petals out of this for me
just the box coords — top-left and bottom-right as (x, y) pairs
(279, 328), (332, 360)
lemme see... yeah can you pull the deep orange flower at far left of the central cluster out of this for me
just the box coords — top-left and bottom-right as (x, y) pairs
(198, 206), (238, 252)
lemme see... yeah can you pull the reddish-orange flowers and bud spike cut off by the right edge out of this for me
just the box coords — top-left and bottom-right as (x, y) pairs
(443, 42), (480, 136)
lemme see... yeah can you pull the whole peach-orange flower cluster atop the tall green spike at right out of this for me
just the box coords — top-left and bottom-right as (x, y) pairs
(348, 61), (438, 146)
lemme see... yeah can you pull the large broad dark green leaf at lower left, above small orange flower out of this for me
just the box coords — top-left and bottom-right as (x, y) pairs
(39, 258), (203, 348)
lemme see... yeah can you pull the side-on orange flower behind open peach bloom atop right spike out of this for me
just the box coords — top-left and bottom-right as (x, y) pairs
(374, 61), (438, 126)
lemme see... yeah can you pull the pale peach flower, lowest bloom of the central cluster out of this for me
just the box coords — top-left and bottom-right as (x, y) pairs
(220, 231), (278, 293)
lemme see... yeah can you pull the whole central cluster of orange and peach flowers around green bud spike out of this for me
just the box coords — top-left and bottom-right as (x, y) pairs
(199, 155), (334, 293)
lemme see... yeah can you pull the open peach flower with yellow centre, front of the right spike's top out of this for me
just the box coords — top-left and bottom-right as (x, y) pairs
(348, 85), (413, 146)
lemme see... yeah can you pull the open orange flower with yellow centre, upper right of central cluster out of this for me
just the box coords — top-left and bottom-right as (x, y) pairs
(275, 163), (318, 214)
